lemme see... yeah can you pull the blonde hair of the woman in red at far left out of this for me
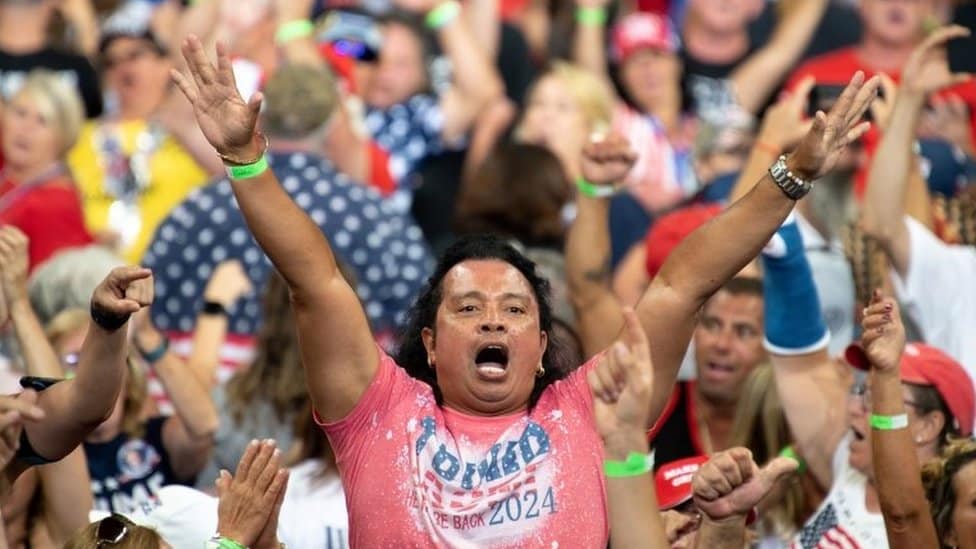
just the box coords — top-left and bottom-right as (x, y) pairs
(14, 69), (85, 156)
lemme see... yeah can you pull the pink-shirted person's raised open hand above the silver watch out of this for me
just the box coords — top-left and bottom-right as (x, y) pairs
(786, 71), (880, 180)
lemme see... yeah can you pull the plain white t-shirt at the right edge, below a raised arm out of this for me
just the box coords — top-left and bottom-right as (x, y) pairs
(892, 217), (976, 379)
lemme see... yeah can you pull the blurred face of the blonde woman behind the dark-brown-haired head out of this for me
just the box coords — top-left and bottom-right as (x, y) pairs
(519, 75), (593, 168)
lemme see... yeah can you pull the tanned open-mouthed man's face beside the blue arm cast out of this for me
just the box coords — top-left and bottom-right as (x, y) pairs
(695, 290), (766, 404)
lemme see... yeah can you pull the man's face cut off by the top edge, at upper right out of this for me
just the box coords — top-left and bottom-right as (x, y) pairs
(860, 0), (932, 47)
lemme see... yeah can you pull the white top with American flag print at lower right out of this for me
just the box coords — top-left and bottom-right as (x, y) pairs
(790, 434), (888, 549)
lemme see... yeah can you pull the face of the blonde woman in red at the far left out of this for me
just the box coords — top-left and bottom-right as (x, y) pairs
(0, 93), (61, 169)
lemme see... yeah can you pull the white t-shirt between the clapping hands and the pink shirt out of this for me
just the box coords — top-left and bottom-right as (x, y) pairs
(278, 459), (349, 549)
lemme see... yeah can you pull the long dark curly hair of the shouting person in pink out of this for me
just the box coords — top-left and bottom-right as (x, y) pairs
(395, 235), (570, 409)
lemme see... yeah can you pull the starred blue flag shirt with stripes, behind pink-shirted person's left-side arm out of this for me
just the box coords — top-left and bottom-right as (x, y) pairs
(143, 152), (433, 410)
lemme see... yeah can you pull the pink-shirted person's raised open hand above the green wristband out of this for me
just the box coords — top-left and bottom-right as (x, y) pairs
(172, 35), (263, 161)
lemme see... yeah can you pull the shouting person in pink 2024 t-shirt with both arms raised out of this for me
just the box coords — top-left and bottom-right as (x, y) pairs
(174, 33), (877, 547)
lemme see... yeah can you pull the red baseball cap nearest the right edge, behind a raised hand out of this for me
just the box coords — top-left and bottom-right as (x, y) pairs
(844, 343), (976, 436)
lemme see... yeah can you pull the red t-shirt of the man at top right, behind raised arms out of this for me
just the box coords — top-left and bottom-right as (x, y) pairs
(786, 47), (976, 196)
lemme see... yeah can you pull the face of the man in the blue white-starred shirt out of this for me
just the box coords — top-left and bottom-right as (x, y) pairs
(365, 24), (427, 109)
